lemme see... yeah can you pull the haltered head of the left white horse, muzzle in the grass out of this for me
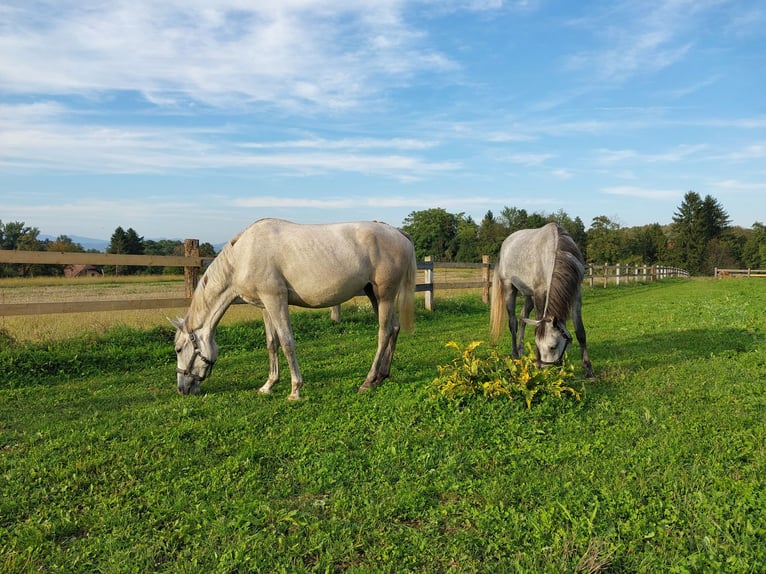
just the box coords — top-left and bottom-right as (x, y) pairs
(170, 319), (218, 395)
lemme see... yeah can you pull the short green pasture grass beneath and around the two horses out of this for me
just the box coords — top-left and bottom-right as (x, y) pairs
(0, 279), (766, 573)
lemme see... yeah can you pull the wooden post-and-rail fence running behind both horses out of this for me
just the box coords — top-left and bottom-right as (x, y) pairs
(0, 245), (688, 319)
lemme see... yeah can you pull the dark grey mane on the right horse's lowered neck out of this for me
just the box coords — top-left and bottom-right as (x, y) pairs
(546, 225), (584, 321)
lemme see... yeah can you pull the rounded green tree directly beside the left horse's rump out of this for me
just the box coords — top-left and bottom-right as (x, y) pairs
(402, 207), (458, 261)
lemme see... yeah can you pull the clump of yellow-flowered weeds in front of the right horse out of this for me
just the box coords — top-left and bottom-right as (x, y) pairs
(432, 341), (580, 409)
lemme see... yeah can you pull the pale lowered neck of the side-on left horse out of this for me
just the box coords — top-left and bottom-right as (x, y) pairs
(186, 256), (237, 331)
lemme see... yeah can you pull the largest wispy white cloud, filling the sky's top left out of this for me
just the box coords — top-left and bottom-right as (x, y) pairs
(0, 0), (468, 109)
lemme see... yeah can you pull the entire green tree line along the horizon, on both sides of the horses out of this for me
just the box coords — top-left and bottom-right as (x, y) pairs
(0, 191), (766, 277)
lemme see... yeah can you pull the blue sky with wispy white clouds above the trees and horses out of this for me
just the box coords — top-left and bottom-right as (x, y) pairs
(0, 0), (766, 243)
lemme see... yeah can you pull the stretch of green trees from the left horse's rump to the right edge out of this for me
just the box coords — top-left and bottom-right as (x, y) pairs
(402, 191), (766, 275)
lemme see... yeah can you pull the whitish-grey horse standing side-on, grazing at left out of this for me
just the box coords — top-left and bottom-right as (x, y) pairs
(171, 219), (417, 400)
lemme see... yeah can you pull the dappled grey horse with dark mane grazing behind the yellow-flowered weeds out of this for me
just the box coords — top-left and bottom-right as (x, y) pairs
(490, 223), (594, 378)
